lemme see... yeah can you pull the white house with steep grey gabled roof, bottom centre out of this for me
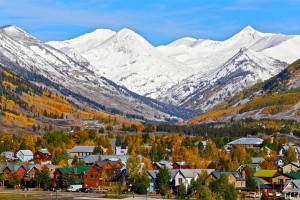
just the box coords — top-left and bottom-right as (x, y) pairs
(174, 169), (215, 190)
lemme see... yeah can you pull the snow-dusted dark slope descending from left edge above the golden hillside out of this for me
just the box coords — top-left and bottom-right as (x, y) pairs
(0, 26), (197, 120)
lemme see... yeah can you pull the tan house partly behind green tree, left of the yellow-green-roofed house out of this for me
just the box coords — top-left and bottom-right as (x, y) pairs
(204, 171), (246, 190)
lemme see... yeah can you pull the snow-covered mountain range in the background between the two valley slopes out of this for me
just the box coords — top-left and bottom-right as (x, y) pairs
(49, 26), (300, 109)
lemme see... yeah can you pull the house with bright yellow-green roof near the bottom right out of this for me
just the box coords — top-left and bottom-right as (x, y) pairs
(254, 169), (290, 190)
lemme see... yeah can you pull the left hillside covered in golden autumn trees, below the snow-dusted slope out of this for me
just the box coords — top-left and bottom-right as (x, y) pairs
(0, 65), (124, 133)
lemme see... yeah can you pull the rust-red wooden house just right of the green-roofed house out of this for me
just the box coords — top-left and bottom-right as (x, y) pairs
(84, 161), (122, 188)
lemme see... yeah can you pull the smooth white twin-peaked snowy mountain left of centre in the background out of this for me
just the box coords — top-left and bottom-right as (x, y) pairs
(48, 29), (190, 98)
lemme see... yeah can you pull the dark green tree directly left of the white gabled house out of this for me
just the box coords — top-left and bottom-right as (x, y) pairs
(156, 168), (171, 196)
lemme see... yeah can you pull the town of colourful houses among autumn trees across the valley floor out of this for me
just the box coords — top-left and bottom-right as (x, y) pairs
(0, 126), (300, 199)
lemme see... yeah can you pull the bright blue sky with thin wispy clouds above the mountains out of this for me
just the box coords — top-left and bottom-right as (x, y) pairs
(0, 0), (300, 45)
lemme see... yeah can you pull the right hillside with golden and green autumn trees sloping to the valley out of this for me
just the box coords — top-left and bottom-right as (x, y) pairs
(189, 59), (300, 124)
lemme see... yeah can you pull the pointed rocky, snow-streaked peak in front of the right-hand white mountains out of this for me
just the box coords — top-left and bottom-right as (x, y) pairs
(161, 48), (288, 110)
